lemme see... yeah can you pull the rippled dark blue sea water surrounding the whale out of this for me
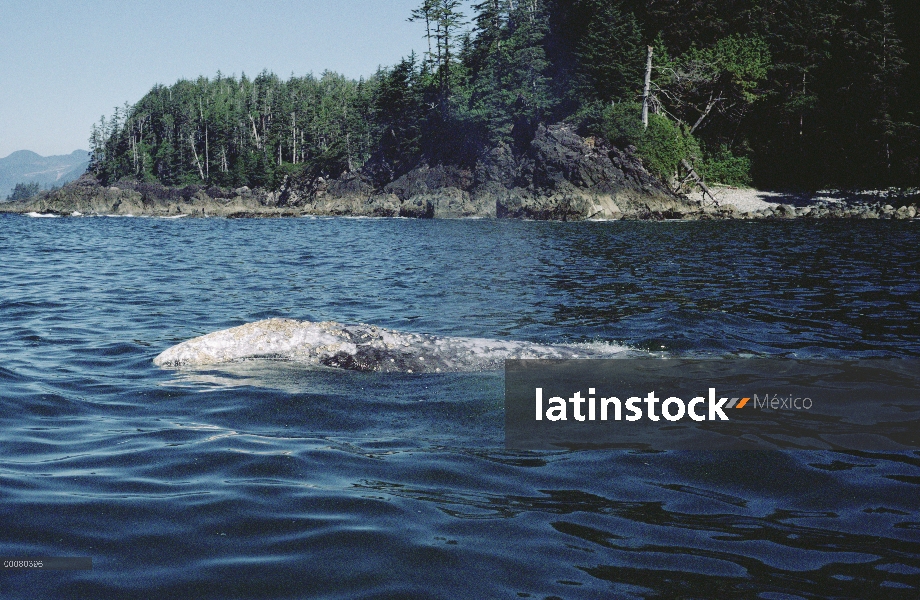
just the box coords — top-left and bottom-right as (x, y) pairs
(0, 215), (920, 599)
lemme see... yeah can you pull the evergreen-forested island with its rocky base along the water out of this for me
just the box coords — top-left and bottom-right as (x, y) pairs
(3, 0), (920, 219)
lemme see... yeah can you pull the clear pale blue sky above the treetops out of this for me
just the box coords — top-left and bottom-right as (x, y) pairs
(0, 0), (470, 158)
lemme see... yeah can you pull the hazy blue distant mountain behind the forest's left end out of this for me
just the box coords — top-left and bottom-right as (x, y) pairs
(0, 150), (89, 202)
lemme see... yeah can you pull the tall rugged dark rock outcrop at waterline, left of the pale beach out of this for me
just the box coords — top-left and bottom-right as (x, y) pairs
(274, 125), (707, 221)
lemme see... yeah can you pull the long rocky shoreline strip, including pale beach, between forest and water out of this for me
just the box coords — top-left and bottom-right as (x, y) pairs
(0, 125), (920, 221)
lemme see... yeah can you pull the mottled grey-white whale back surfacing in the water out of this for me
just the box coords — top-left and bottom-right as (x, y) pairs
(153, 319), (625, 373)
